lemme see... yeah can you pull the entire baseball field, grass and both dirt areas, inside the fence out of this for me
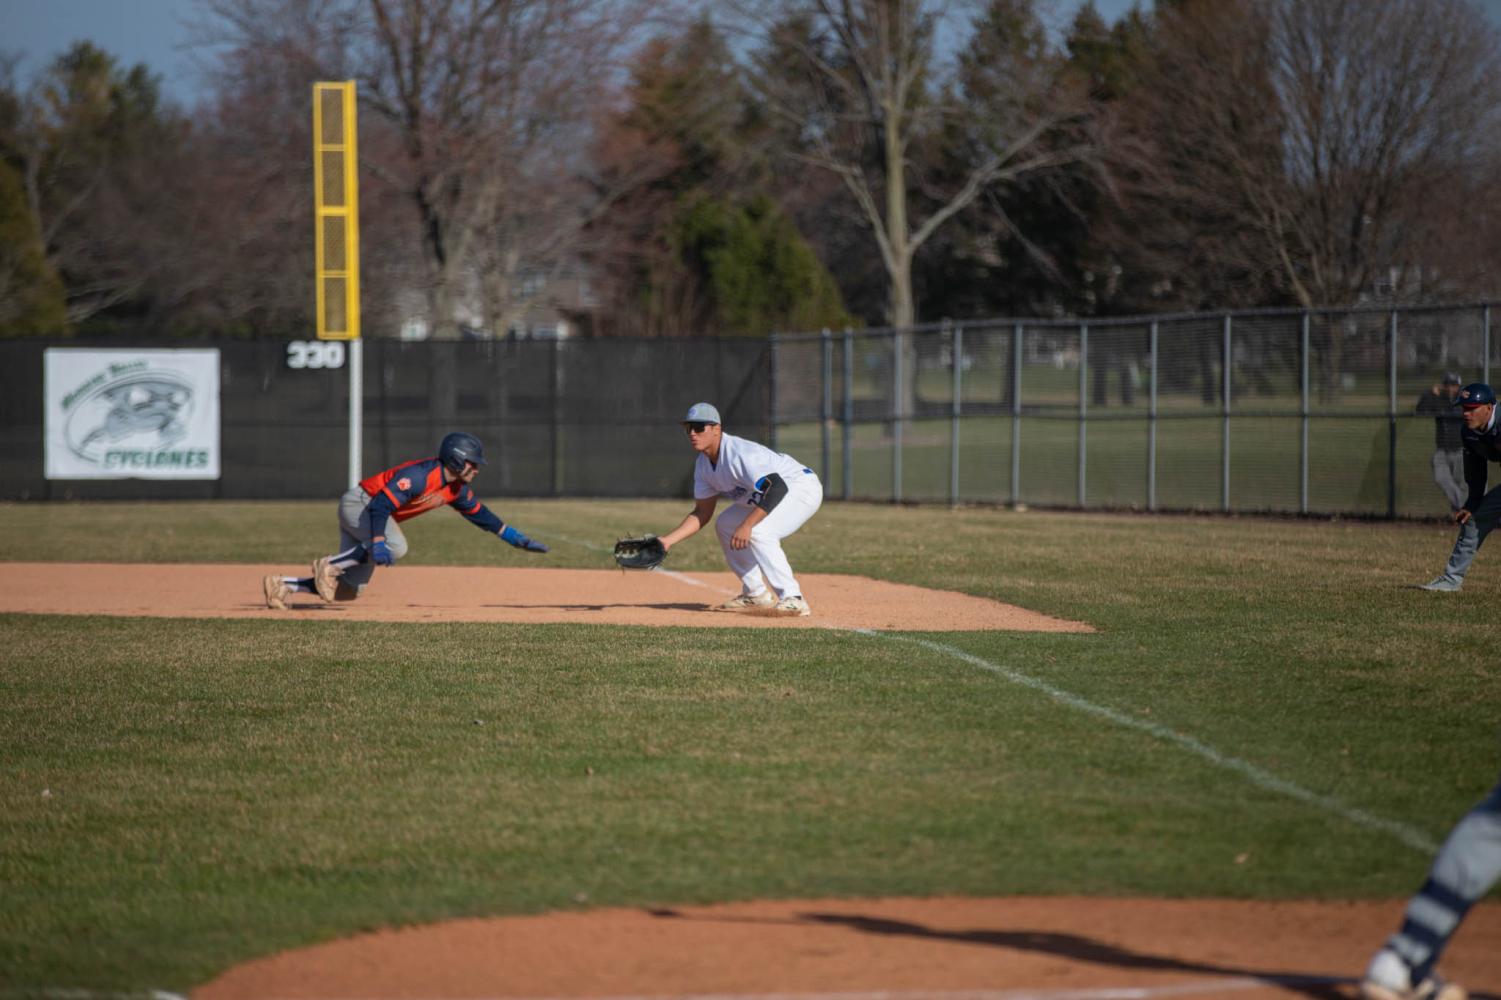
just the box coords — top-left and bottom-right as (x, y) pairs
(0, 498), (1501, 1000)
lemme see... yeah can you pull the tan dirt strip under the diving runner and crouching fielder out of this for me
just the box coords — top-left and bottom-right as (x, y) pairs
(0, 563), (1093, 632)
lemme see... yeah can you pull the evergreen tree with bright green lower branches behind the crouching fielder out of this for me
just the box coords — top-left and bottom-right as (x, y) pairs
(596, 21), (850, 336)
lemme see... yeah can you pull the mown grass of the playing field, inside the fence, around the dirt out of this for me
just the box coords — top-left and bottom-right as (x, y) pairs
(0, 498), (1501, 995)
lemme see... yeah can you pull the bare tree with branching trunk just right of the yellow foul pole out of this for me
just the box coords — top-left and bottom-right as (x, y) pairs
(362, 0), (663, 339)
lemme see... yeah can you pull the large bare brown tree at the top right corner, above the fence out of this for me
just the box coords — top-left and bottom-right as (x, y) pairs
(1114, 0), (1501, 306)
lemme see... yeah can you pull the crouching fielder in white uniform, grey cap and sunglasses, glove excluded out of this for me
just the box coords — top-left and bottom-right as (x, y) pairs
(662, 402), (824, 617)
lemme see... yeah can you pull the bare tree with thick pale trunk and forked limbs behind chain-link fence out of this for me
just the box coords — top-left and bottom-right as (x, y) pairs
(740, 0), (1091, 327)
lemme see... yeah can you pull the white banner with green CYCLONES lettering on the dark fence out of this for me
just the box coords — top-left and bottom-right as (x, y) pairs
(42, 347), (219, 479)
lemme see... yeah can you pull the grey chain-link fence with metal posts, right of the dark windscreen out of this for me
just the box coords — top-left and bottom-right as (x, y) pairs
(770, 303), (1501, 517)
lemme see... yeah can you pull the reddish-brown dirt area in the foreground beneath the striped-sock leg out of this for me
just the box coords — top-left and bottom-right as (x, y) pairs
(192, 898), (1501, 1000)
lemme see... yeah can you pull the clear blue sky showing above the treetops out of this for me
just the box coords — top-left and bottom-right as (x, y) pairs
(0, 0), (1501, 104)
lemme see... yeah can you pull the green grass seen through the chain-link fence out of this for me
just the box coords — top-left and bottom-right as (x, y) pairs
(778, 413), (1448, 518)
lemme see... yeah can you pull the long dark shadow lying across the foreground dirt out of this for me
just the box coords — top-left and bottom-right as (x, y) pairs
(650, 908), (1362, 1000)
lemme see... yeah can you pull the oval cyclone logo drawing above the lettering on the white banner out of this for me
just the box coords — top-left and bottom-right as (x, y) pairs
(63, 371), (194, 464)
